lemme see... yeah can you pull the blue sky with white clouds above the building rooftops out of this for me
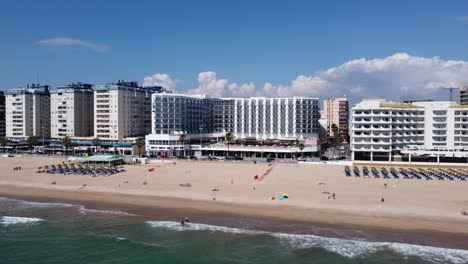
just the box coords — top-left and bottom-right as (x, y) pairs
(0, 0), (468, 102)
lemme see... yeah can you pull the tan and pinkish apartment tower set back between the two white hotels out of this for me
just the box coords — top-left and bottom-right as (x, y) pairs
(320, 97), (349, 142)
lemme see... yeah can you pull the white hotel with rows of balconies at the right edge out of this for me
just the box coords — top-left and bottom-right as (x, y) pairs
(351, 99), (468, 162)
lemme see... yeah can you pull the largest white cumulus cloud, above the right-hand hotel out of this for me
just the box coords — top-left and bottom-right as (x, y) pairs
(260, 53), (468, 100)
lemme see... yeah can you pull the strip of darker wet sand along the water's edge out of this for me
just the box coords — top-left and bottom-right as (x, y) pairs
(0, 185), (468, 250)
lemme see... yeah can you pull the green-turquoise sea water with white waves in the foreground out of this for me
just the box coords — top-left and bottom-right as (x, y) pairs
(0, 198), (468, 264)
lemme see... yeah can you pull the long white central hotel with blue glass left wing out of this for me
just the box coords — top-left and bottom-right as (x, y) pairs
(146, 93), (319, 157)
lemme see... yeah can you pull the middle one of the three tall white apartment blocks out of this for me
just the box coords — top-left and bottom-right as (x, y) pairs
(50, 82), (94, 138)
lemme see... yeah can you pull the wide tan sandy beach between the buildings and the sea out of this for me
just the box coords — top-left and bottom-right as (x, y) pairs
(0, 156), (468, 235)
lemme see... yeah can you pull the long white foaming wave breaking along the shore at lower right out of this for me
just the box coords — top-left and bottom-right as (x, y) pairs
(147, 221), (468, 264)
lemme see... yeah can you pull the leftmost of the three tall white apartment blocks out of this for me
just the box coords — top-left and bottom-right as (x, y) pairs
(5, 84), (50, 139)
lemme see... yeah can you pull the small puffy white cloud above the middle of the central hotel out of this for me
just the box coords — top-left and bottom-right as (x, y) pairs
(188, 71), (256, 97)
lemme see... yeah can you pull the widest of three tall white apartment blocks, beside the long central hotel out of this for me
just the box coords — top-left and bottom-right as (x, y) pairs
(93, 81), (161, 142)
